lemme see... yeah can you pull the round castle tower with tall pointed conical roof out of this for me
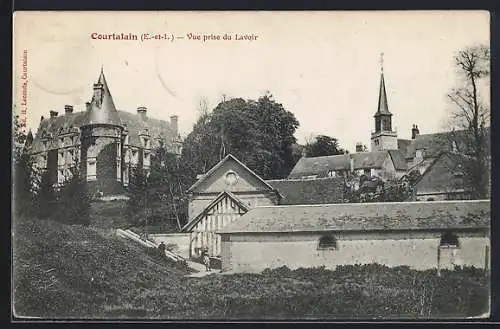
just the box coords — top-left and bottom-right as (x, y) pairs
(81, 68), (123, 193)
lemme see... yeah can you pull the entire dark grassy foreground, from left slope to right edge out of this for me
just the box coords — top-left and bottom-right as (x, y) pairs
(14, 220), (489, 319)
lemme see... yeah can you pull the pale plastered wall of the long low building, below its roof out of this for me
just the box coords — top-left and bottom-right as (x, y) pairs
(222, 233), (490, 272)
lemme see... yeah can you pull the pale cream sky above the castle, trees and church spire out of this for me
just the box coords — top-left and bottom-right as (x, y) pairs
(13, 11), (490, 151)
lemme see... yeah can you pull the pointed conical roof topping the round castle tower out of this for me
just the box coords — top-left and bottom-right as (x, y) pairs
(86, 68), (121, 125)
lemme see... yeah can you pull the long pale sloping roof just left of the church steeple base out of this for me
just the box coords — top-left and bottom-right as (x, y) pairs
(288, 151), (388, 179)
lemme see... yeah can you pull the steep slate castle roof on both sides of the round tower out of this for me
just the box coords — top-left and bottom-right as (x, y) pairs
(32, 111), (176, 153)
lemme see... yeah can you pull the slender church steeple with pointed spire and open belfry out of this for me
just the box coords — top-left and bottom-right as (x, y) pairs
(371, 54), (398, 151)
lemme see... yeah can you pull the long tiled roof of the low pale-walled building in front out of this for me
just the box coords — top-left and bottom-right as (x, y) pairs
(219, 200), (491, 233)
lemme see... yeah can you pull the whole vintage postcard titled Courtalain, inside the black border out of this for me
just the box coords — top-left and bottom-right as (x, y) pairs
(11, 10), (491, 321)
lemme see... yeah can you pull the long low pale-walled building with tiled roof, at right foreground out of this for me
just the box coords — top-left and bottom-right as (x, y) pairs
(218, 200), (491, 272)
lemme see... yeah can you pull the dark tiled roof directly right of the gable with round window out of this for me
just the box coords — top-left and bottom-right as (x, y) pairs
(266, 178), (344, 205)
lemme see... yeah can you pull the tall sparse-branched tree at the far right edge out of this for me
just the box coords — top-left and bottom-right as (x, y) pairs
(448, 46), (490, 198)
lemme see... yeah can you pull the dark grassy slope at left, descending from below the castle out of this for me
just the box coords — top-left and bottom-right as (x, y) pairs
(13, 220), (193, 317)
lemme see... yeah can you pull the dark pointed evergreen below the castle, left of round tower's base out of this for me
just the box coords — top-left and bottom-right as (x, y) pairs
(55, 166), (92, 225)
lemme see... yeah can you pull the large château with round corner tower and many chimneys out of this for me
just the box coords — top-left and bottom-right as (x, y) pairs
(27, 69), (182, 195)
